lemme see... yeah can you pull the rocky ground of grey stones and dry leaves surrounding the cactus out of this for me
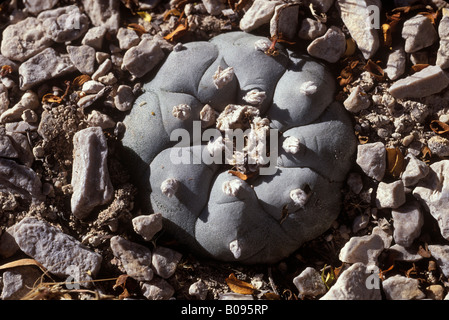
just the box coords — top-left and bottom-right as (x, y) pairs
(0, 0), (449, 300)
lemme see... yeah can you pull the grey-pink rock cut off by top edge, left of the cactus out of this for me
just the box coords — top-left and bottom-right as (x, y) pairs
(82, 0), (120, 31)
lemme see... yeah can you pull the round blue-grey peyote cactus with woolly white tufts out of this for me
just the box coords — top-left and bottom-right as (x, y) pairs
(122, 32), (356, 264)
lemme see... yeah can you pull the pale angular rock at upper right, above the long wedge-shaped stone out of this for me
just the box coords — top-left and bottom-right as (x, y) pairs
(402, 14), (438, 53)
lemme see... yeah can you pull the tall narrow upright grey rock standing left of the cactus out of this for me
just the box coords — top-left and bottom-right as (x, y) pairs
(71, 127), (114, 219)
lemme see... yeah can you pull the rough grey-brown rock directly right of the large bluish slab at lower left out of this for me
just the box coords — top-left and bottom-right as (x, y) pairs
(110, 236), (154, 281)
